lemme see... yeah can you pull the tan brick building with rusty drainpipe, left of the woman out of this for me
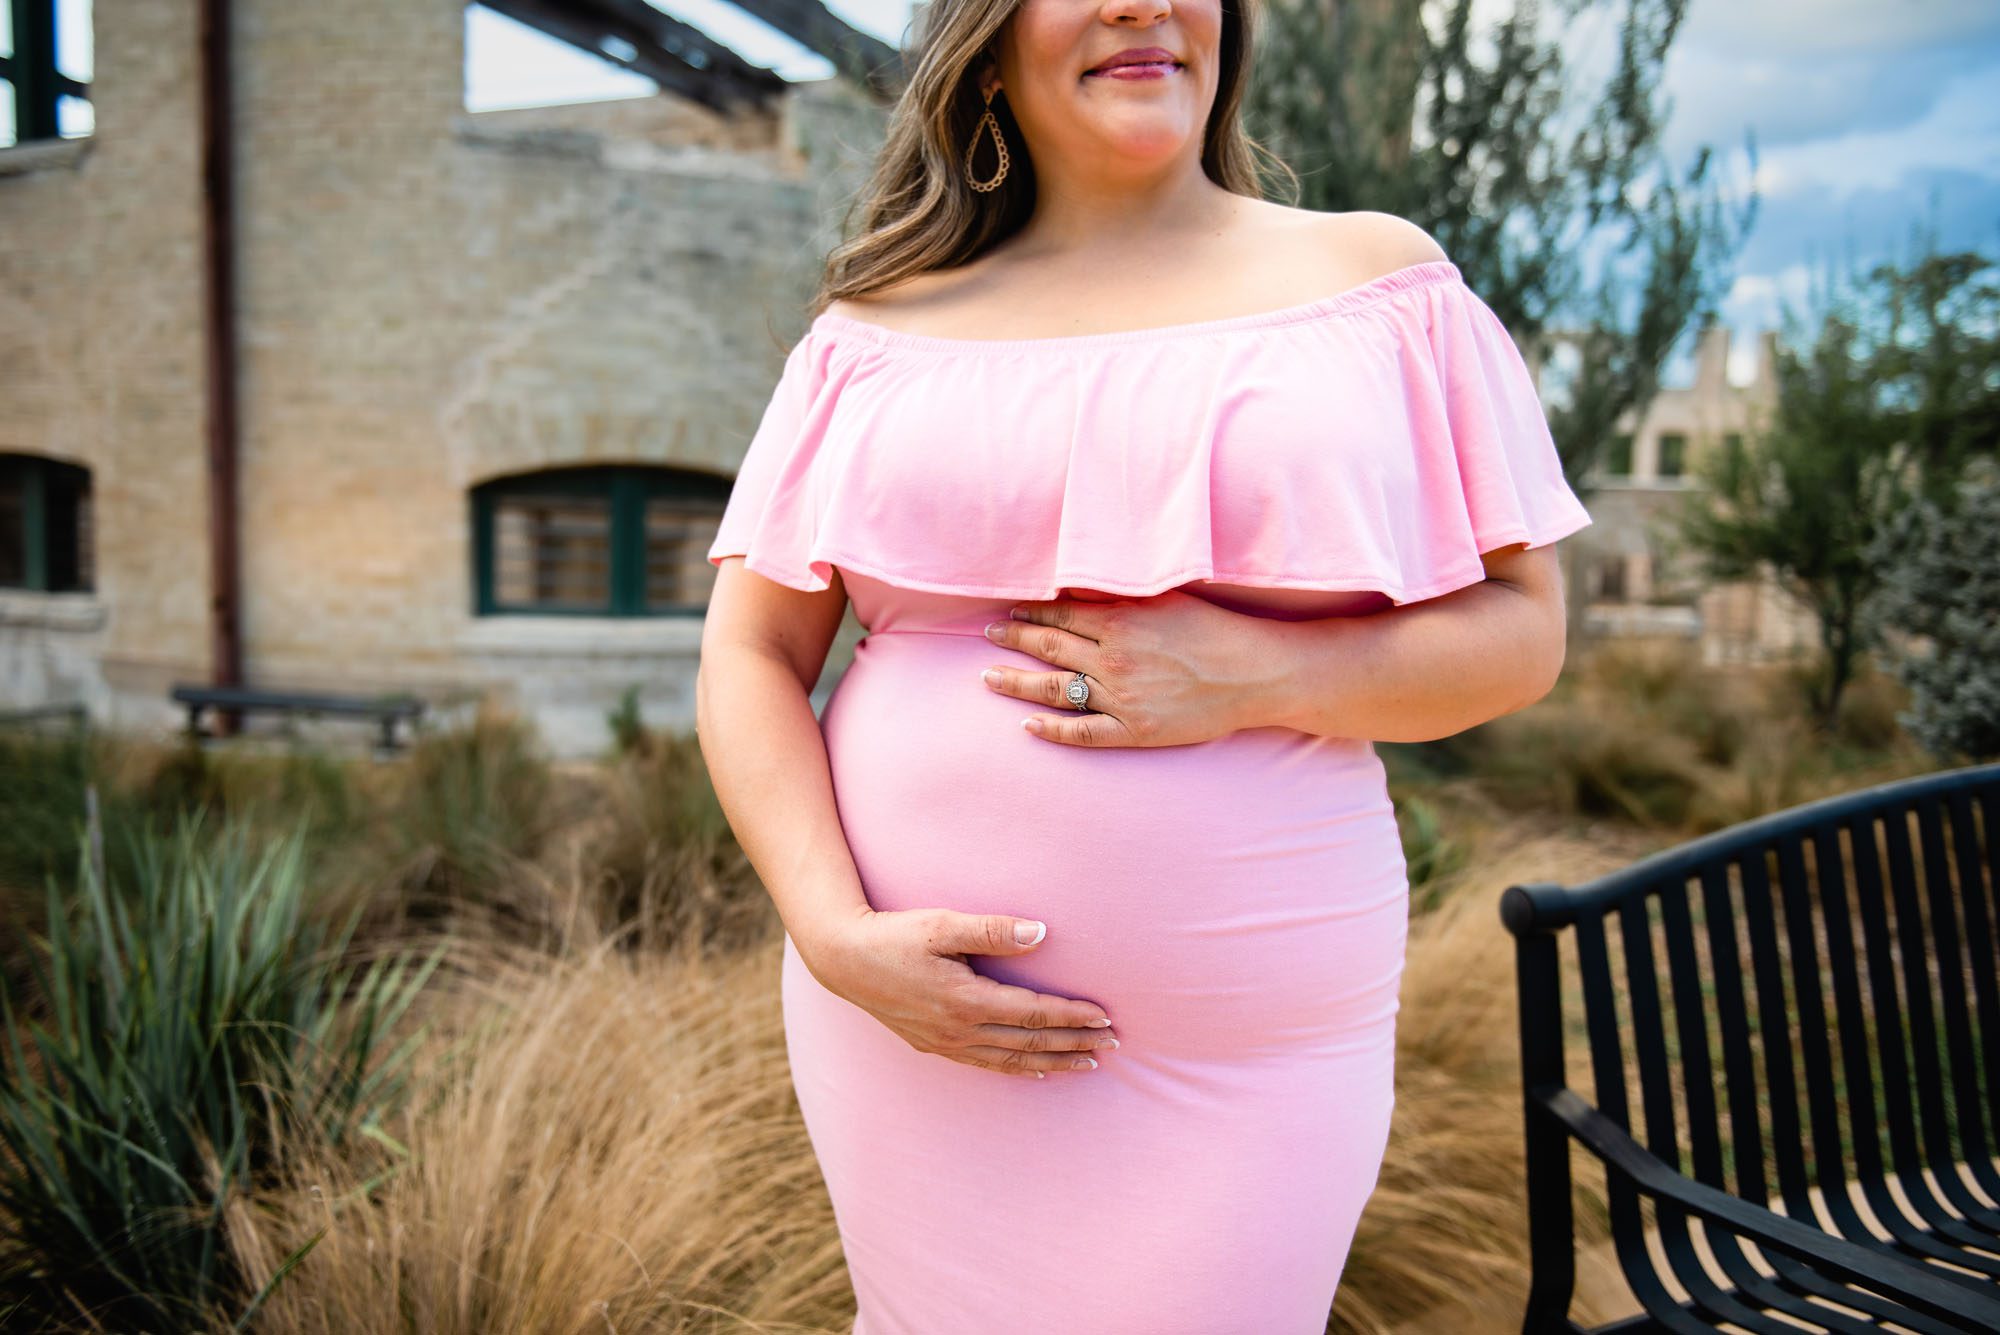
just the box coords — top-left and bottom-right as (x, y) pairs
(0, 0), (898, 753)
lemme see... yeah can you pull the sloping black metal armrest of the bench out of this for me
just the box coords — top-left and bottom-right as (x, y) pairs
(1538, 1089), (2000, 1331)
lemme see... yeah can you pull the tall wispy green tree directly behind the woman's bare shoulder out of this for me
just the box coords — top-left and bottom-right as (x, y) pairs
(1244, 0), (1758, 655)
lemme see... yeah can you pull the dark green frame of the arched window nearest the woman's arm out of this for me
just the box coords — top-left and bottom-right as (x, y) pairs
(470, 464), (732, 618)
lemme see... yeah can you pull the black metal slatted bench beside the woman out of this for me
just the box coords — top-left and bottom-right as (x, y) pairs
(1500, 763), (2000, 1335)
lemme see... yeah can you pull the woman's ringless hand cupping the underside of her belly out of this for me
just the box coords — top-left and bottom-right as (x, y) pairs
(802, 909), (1118, 1079)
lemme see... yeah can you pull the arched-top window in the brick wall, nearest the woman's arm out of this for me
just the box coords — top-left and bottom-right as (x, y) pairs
(472, 464), (730, 616)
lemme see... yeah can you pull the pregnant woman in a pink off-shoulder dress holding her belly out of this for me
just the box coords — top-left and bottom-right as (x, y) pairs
(698, 0), (1590, 1335)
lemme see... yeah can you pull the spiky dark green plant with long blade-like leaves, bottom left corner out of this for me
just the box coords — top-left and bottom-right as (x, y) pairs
(0, 791), (438, 1329)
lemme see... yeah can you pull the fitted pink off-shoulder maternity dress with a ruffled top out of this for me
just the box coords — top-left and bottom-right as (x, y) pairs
(708, 260), (1590, 1335)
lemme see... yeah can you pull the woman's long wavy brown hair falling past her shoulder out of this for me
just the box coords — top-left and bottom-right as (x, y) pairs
(808, 0), (1296, 318)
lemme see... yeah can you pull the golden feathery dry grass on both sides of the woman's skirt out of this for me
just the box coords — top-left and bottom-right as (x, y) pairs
(230, 819), (1656, 1335)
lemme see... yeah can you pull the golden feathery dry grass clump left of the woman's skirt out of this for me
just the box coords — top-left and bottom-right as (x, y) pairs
(230, 923), (852, 1335)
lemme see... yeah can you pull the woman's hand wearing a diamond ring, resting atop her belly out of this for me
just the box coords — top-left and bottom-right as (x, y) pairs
(984, 590), (1258, 745)
